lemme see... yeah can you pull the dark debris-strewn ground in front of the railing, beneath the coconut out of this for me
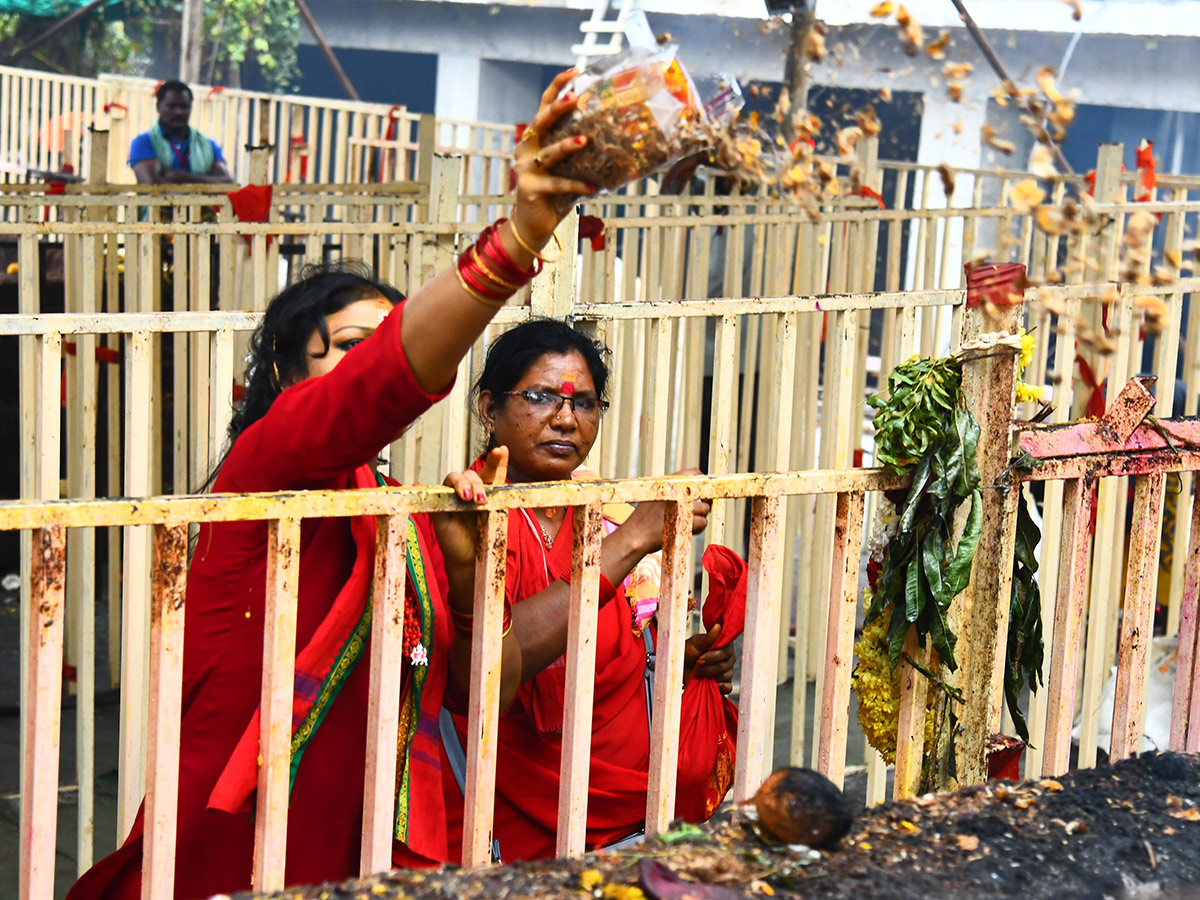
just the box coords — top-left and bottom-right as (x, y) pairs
(229, 754), (1200, 900)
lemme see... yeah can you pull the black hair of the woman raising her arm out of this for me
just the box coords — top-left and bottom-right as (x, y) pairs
(229, 260), (404, 446)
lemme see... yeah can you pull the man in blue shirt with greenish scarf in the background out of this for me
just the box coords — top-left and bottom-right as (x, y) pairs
(130, 80), (233, 185)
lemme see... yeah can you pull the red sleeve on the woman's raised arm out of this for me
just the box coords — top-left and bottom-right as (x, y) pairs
(218, 304), (454, 491)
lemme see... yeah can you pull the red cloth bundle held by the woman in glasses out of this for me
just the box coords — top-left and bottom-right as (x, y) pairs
(676, 544), (746, 822)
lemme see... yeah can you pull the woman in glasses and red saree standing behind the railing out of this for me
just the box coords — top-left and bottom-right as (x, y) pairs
(438, 319), (744, 862)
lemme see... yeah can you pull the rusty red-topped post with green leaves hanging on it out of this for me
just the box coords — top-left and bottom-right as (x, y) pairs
(948, 292), (1021, 785)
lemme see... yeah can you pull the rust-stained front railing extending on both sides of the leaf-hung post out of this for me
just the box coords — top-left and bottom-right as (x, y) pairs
(14, 296), (1200, 900)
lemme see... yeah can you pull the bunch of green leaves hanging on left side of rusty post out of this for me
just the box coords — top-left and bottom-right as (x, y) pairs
(866, 358), (983, 672)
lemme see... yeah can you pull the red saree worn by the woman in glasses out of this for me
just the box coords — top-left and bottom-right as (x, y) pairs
(445, 461), (744, 862)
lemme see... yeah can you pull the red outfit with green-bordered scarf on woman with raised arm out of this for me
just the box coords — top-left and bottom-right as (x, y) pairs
(68, 307), (451, 900)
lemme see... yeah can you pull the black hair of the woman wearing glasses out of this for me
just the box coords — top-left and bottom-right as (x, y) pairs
(472, 319), (608, 441)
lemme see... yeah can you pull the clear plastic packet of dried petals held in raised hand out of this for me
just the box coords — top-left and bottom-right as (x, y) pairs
(542, 44), (706, 204)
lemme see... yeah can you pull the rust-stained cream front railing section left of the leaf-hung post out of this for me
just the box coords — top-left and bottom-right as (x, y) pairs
(14, 469), (904, 900)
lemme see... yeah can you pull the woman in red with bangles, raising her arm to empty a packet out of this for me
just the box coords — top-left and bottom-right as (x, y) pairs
(70, 72), (590, 900)
